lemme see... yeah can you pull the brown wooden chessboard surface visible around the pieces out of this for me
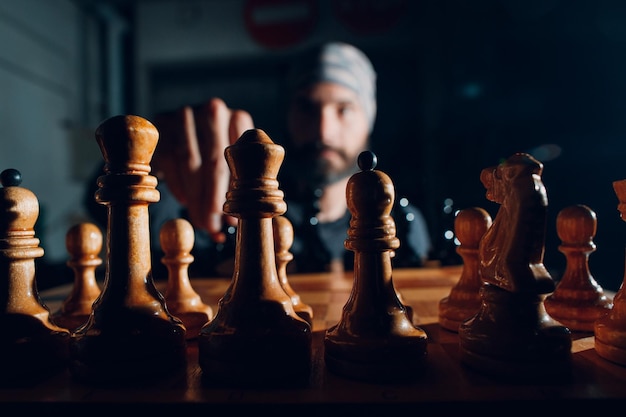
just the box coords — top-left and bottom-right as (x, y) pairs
(0, 266), (626, 416)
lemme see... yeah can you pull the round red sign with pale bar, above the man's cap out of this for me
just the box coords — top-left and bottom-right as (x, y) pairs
(244, 0), (319, 48)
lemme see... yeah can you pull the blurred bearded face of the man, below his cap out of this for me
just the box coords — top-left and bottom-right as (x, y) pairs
(288, 82), (369, 185)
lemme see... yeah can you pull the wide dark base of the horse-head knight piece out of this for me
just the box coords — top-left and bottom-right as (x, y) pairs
(459, 284), (572, 379)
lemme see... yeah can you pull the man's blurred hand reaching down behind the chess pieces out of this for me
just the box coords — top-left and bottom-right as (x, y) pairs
(152, 98), (254, 242)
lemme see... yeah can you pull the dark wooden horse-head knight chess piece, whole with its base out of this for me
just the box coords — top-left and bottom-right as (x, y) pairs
(458, 153), (572, 380)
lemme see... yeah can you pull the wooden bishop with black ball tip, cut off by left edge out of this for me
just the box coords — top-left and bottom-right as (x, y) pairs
(0, 169), (70, 386)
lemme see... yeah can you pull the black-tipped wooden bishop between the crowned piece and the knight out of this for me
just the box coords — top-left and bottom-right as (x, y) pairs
(324, 151), (428, 382)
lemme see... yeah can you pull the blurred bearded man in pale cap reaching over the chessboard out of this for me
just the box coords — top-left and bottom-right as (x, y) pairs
(88, 42), (430, 276)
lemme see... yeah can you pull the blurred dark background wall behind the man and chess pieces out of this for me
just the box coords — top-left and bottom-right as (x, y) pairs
(0, 0), (626, 290)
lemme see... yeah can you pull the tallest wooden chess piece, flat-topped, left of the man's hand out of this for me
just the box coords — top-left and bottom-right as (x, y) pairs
(70, 115), (187, 384)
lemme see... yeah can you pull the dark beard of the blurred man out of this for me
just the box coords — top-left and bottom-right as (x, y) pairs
(295, 142), (359, 188)
